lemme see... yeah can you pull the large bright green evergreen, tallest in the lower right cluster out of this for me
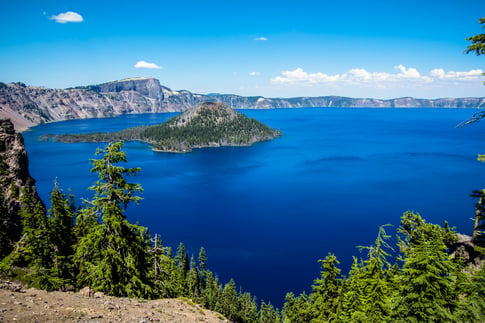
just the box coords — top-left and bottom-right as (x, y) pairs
(392, 212), (457, 322)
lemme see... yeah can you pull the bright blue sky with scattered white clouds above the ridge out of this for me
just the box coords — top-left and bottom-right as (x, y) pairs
(0, 0), (485, 98)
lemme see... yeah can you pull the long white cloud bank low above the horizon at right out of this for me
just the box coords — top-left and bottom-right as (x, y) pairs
(271, 65), (484, 88)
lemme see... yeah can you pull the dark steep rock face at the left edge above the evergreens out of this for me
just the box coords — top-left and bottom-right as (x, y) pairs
(0, 119), (40, 252)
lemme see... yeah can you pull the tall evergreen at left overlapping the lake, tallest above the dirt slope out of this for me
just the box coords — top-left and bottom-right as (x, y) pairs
(74, 142), (151, 298)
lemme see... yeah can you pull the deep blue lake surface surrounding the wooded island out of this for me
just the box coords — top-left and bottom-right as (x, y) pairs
(23, 108), (485, 307)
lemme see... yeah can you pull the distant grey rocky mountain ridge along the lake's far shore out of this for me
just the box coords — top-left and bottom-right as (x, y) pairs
(0, 77), (485, 130)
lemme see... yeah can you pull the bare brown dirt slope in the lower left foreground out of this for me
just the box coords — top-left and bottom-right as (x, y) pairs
(0, 281), (229, 323)
